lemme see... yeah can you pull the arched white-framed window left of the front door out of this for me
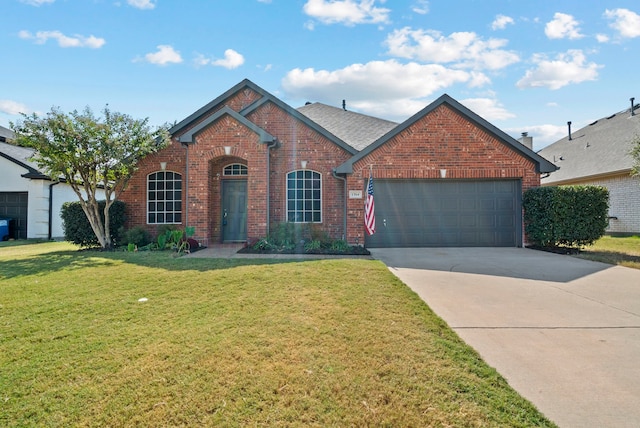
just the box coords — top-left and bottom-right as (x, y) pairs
(147, 171), (182, 224)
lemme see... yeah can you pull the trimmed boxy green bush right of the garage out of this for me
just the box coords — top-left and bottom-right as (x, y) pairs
(522, 186), (609, 248)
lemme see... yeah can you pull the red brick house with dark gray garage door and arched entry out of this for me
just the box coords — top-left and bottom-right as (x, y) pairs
(121, 80), (555, 247)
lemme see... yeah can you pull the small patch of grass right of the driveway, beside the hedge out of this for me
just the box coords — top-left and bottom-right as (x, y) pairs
(577, 236), (640, 269)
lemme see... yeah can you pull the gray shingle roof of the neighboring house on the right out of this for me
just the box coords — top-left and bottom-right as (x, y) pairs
(539, 105), (640, 184)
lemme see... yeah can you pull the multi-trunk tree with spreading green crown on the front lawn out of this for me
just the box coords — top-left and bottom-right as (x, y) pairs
(11, 107), (169, 249)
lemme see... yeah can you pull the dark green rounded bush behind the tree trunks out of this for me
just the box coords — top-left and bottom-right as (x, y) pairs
(60, 201), (125, 248)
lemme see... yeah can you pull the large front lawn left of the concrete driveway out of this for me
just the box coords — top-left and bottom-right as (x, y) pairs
(0, 243), (553, 427)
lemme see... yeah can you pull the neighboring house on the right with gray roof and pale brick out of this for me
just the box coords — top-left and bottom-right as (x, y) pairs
(539, 100), (640, 234)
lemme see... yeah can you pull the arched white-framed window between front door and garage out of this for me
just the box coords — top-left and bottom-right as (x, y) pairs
(287, 170), (322, 223)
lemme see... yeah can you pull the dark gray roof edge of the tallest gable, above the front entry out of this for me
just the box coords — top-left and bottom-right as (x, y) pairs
(169, 79), (358, 154)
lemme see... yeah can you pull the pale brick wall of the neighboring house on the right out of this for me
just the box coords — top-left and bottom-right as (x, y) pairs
(546, 174), (640, 234)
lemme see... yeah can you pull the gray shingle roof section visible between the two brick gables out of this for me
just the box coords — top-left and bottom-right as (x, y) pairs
(297, 103), (398, 150)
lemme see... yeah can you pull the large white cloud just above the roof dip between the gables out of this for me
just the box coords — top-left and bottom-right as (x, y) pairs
(282, 60), (488, 120)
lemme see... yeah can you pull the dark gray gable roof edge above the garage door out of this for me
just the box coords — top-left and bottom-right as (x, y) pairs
(336, 94), (557, 174)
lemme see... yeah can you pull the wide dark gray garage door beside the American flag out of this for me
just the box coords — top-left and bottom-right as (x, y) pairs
(366, 180), (522, 248)
